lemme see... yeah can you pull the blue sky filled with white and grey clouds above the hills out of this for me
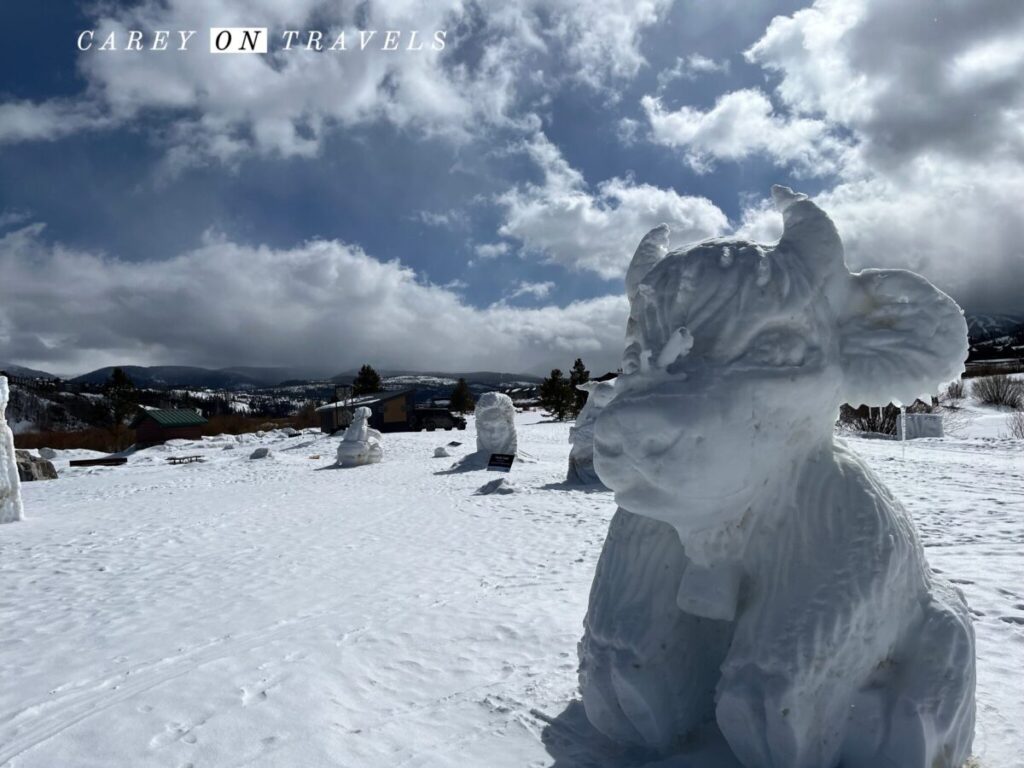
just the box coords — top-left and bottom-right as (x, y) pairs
(0, 0), (1024, 373)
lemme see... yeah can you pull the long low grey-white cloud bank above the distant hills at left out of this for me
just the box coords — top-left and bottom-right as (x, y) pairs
(0, 224), (627, 372)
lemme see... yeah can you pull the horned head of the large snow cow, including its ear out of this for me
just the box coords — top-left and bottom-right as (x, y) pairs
(595, 186), (967, 544)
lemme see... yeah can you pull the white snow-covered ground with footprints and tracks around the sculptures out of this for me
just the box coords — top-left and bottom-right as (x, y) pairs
(0, 414), (1024, 768)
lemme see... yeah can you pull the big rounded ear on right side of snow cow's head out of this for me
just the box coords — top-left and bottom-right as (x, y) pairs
(839, 269), (968, 406)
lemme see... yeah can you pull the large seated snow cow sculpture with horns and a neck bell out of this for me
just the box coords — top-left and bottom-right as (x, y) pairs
(580, 187), (975, 768)
